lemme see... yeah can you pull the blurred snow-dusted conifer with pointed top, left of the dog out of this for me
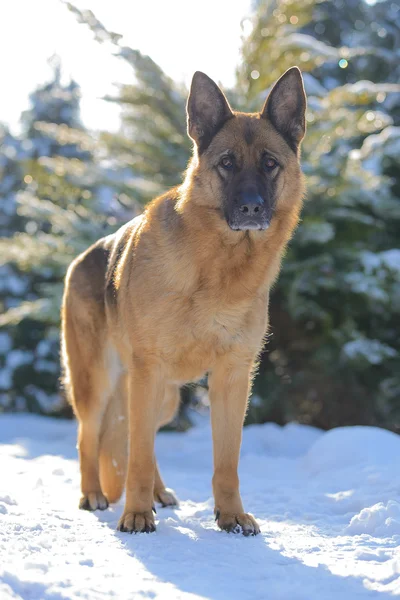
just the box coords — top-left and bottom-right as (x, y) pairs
(0, 59), (116, 414)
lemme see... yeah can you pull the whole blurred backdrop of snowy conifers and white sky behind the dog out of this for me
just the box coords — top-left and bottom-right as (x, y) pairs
(0, 0), (400, 430)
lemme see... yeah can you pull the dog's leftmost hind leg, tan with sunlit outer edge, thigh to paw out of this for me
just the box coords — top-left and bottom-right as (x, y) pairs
(62, 251), (110, 510)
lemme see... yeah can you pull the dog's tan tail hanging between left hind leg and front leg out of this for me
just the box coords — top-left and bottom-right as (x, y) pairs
(99, 374), (128, 503)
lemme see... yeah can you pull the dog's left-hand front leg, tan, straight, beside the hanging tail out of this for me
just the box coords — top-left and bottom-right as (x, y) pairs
(117, 361), (165, 533)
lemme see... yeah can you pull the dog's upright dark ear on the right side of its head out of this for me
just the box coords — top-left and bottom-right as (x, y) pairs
(261, 67), (307, 150)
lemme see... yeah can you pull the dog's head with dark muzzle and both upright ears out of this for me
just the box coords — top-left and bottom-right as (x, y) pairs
(187, 67), (306, 231)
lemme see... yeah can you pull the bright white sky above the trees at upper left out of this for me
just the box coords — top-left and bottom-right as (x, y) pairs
(0, 0), (251, 131)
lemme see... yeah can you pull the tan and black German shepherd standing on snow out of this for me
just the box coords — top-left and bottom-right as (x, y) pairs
(62, 67), (306, 536)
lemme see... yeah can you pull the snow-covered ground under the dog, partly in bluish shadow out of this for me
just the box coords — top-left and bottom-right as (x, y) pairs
(0, 415), (400, 600)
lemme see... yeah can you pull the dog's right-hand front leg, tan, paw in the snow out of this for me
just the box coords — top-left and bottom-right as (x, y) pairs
(209, 360), (260, 535)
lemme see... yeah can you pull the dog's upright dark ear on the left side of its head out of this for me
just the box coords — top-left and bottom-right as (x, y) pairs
(186, 71), (233, 153)
